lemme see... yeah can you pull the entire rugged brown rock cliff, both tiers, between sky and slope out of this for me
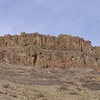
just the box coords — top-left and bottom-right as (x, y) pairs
(0, 32), (100, 68)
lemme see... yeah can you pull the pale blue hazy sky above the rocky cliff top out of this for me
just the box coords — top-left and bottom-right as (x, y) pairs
(0, 0), (100, 45)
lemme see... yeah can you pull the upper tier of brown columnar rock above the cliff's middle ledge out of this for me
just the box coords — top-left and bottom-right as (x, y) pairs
(0, 32), (91, 52)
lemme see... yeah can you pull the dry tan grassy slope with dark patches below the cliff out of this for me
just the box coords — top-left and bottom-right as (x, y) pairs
(0, 64), (100, 100)
